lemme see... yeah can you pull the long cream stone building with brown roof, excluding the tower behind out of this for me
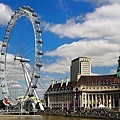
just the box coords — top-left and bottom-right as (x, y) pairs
(45, 75), (120, 109)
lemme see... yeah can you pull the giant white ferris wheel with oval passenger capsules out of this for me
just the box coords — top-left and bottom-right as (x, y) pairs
(0, 6), (43, 109)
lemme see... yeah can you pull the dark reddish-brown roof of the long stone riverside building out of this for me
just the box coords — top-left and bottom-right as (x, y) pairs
(47, 74), (120, 91)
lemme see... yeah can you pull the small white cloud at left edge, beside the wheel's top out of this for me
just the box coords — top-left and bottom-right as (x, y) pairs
(0, 3), (13, 25)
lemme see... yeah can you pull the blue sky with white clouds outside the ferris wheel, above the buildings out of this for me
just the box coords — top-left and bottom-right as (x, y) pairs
(0, 0), (120, 97)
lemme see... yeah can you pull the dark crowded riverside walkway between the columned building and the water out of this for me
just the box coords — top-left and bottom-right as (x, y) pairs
(38, 109), (120, 120)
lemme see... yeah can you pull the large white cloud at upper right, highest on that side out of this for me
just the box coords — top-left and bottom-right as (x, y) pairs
(45, 4), (120, 39)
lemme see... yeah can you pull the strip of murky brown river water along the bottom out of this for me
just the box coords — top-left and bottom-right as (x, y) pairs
(0, 115), (105, 120)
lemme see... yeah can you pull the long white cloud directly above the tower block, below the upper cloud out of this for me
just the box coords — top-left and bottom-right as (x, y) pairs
(45, 40), (119, 58)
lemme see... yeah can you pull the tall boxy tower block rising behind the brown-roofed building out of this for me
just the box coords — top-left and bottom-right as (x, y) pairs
(70, 57), (91, 81)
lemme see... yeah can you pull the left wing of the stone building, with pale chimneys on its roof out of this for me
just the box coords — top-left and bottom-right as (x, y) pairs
(44, 78), (76, 109)
